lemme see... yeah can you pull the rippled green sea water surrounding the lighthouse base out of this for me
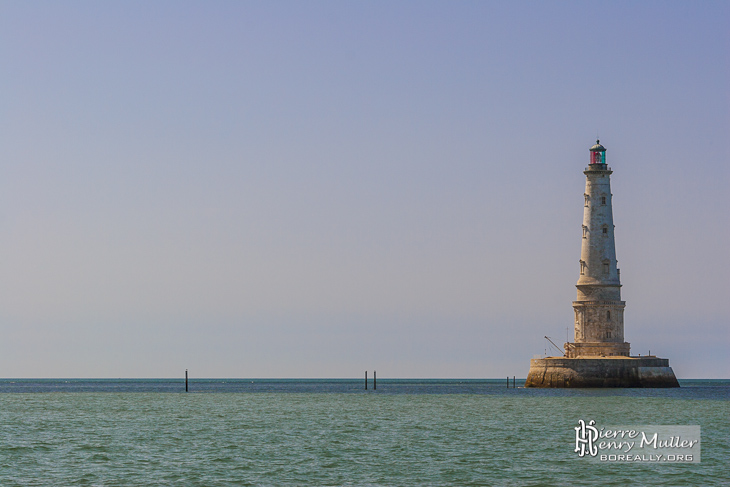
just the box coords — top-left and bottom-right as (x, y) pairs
(0, 379), (730, 487)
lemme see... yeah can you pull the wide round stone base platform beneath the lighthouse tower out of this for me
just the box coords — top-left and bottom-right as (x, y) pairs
(525, 356), (679, 388)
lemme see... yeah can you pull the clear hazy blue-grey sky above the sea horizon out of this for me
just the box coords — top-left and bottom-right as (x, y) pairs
(0, 0), (730, 379)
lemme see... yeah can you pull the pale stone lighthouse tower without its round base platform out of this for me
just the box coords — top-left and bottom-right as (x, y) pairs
(565, 140), (629, 358)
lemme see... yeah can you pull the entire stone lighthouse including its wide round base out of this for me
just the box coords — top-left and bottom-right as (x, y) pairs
(525, 140), (679, 387)
